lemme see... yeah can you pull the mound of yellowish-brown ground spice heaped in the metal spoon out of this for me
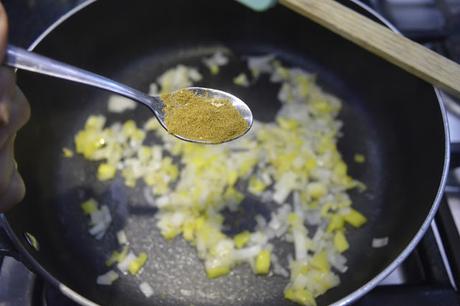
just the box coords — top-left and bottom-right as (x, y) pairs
(161, 89), (248, 143)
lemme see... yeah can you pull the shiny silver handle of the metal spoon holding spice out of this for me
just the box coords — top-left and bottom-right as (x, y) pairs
(4, 45), (154, 109)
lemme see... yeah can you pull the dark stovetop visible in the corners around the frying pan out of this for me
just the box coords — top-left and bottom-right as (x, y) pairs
(0, 0), (460, 306)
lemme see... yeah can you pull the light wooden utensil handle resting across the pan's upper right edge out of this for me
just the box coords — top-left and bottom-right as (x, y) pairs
(280, 0), (460, 97)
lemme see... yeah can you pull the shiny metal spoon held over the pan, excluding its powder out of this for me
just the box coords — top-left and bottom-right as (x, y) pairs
(4, 45), (253, 144)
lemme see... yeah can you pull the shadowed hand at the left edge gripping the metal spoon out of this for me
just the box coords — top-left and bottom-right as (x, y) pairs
(0, 3), (30, 213)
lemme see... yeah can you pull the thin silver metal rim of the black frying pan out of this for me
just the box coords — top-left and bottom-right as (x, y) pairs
(0, 0), (450, 306)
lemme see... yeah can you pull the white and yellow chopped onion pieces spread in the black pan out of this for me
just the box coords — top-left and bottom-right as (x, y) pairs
(75, 54), (370, 304)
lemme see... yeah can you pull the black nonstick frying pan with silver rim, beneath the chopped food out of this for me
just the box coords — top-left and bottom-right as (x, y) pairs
(0, 0), (449, 305)
